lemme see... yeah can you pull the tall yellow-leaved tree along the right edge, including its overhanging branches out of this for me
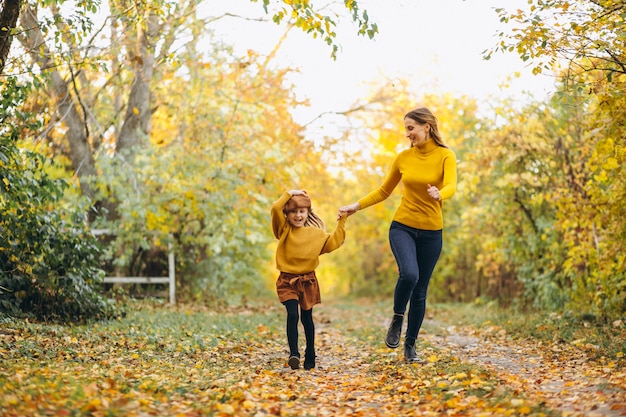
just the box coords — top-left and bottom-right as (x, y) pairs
(487, 0), (626, 319)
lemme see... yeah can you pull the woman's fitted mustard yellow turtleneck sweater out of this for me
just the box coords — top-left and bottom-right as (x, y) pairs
(359, 139), (457, 230)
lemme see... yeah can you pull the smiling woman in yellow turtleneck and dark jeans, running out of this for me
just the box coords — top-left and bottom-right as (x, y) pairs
(339, 107), (457, 363)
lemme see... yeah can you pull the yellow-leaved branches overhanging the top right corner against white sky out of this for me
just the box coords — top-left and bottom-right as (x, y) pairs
(486, 0), (626, 82)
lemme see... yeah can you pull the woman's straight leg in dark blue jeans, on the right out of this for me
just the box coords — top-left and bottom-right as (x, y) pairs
(406, 230), (443, 346)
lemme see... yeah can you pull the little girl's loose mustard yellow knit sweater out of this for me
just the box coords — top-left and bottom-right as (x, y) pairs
(272, 192), (346, 274)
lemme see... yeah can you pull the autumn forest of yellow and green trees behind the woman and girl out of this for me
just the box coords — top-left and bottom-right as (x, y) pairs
(0, 0), (626, 322)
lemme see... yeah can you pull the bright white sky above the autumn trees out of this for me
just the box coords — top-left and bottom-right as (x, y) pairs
(197, 0), (554, 132)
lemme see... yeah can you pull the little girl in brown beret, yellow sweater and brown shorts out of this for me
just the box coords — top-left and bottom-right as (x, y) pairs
(272, 190), (347, 369)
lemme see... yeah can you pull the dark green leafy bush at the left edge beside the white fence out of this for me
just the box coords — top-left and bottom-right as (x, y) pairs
(0, 79), (112, 321)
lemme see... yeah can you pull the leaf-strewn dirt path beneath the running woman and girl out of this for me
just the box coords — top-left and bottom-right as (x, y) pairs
(243, 307), (626, 417)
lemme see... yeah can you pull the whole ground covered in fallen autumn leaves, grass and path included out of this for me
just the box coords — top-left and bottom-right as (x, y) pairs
(0, 303), (626, 417)
